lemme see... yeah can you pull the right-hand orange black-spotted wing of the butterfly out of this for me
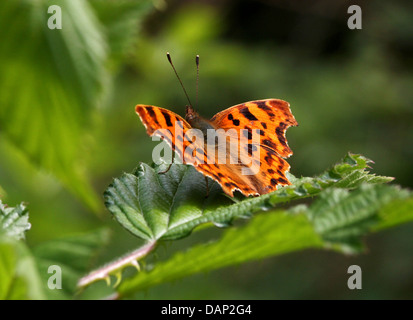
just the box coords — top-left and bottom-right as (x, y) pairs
(211, 99), (298, 195)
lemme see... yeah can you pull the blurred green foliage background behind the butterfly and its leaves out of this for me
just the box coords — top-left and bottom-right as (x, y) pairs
(0, 0), (413, 299)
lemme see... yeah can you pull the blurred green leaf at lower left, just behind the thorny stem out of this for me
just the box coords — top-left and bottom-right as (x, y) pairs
(33, 229), (110, 299)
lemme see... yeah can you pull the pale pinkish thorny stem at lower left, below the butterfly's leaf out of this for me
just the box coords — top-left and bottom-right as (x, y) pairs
(77, 241), (156, 288)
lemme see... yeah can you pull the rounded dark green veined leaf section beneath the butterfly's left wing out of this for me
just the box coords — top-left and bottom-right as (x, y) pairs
(104, 163), (232, 240)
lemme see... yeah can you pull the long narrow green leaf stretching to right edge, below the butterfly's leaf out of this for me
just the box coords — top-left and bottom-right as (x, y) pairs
(118, 185), (413, 297)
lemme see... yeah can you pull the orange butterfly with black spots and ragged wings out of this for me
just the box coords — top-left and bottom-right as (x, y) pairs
(135, 99), (298, 197)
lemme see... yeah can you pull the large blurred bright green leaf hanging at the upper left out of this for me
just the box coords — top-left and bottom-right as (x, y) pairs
(0, 0), (108, 210)
